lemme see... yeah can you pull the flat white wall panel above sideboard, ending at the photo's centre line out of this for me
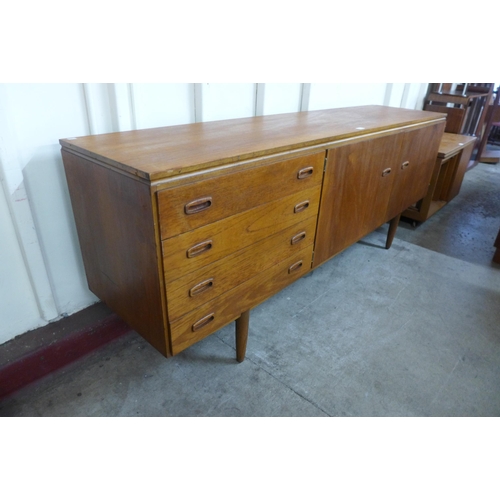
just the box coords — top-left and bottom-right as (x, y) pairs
(201, 83), (257, 122)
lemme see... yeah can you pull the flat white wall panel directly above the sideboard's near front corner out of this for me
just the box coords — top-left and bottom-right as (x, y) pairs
(132, 83), (195, 129)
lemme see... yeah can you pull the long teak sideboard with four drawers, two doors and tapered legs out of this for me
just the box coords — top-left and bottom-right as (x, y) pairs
(60, 106), (445, 361)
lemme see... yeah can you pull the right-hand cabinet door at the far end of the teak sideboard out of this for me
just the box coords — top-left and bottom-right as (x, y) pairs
(384, 123), (445, 222)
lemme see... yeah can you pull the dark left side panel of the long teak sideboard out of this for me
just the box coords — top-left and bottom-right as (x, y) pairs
(62, 150), (169, 356)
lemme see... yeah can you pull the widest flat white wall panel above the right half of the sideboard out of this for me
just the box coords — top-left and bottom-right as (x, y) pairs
(309, 83), (387, 110)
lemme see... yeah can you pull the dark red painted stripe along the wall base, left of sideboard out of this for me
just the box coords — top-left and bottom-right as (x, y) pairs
(0, 314), (132, 399)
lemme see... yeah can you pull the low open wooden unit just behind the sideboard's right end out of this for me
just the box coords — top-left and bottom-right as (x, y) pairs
(402, 133), (475, 222)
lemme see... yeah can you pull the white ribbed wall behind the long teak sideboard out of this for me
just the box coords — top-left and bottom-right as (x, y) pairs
(0, 83), (427, 344)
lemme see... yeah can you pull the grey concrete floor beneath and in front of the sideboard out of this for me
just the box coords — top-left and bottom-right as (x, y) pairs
(0, 164), (500, 416)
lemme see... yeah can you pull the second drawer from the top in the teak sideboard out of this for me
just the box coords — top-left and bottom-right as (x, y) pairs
(162, 184), (321, 283)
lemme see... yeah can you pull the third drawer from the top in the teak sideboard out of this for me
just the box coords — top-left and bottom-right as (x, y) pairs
(167, 217), (316, 321)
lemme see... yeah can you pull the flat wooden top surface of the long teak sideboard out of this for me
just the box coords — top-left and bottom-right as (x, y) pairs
(60, 106), (446, 181)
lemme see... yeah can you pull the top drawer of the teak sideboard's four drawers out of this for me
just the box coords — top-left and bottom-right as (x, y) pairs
(158, 152), (325, 239)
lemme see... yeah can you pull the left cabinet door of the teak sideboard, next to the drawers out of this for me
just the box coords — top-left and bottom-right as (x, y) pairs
(313, 134), (400, 266)
